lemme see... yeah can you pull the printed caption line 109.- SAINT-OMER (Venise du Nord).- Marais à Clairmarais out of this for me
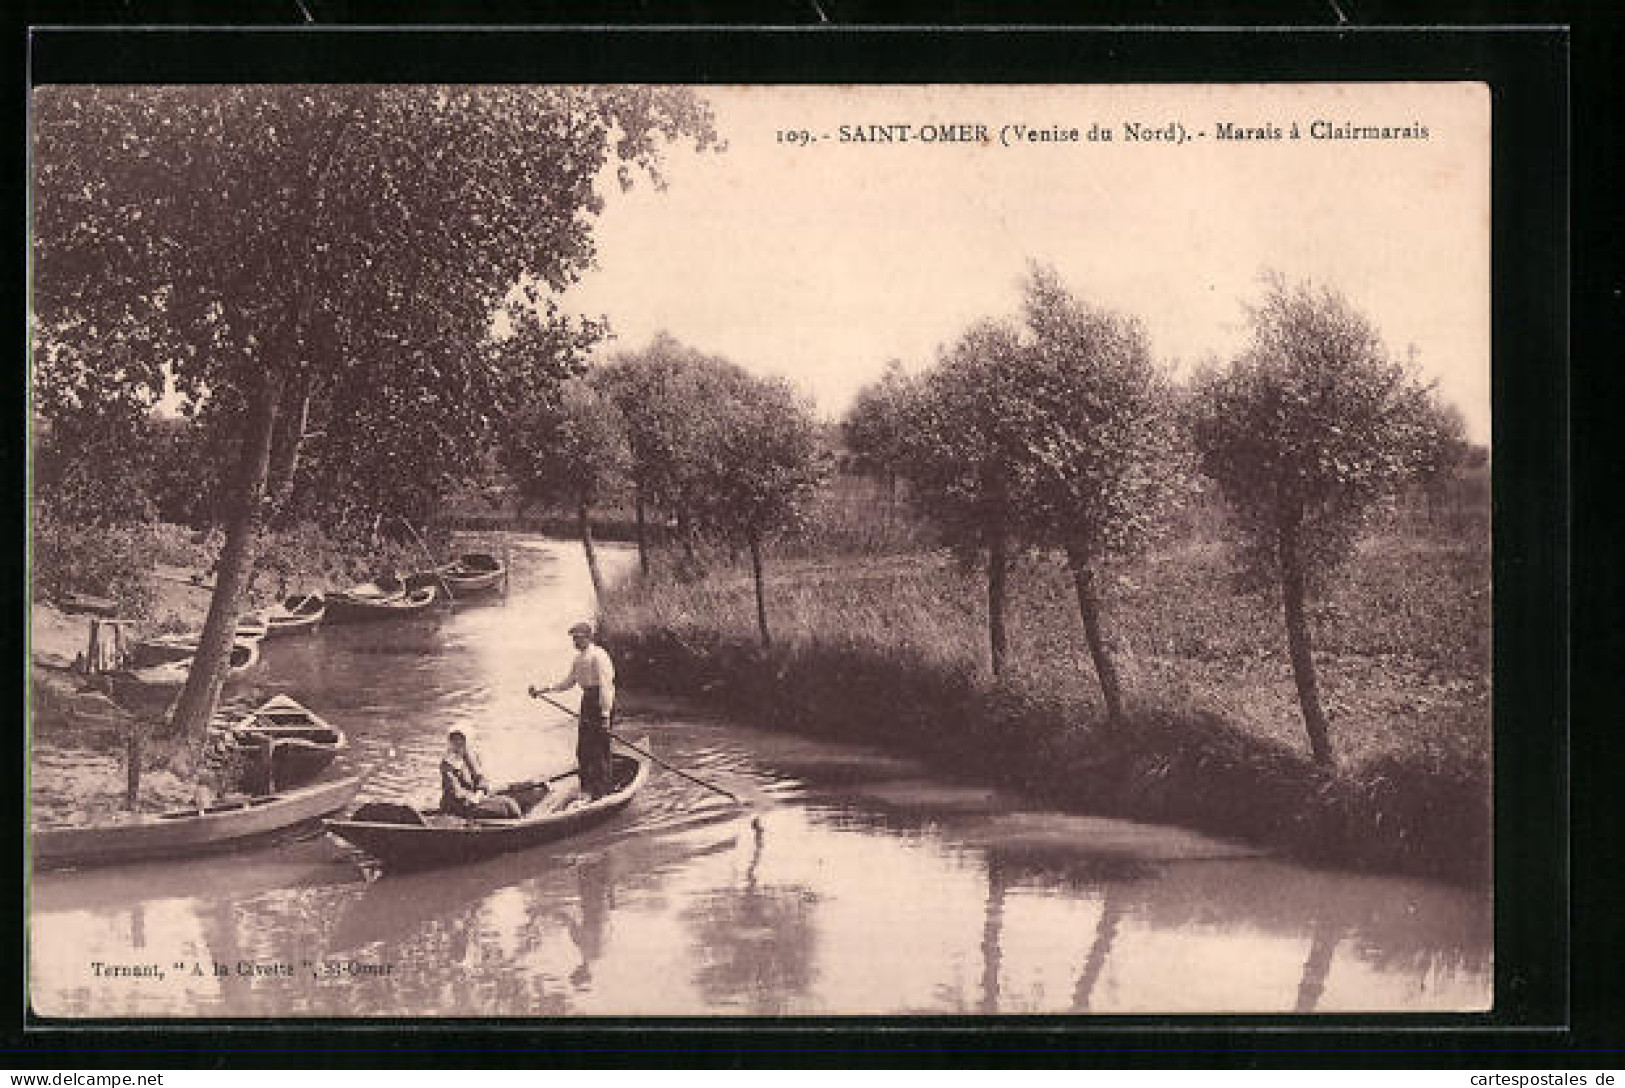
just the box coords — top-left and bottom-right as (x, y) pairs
(775, 119), (1432, 148)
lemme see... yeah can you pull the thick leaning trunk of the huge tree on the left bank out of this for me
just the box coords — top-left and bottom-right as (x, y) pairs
(172, 373), (283, 739)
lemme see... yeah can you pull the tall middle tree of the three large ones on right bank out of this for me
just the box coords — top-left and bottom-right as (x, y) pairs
(1006, 266), (1190, 724)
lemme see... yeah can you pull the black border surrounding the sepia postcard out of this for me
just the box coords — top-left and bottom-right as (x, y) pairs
(0, 17), (1579, 1065)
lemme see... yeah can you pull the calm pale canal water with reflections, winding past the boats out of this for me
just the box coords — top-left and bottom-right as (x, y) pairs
(29, 538), (1492, 1017)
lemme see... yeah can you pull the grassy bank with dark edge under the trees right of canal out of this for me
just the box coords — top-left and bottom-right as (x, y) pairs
(608, 534), (1490, 879)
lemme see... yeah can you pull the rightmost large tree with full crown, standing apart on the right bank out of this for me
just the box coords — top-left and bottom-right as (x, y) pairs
(1196, 279), (1440, 765)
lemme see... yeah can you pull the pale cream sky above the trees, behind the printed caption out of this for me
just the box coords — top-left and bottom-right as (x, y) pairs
(566, 83), (1490, 443)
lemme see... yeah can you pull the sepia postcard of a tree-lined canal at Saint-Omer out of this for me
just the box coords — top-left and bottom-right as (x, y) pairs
(26, 83), (1497, 1023)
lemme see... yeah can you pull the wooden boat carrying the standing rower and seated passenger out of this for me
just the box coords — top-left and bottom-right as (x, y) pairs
(323, 740), (648, 869)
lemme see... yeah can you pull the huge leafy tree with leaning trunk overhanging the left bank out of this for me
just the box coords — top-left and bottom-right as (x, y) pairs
(33, 86), (715, 734)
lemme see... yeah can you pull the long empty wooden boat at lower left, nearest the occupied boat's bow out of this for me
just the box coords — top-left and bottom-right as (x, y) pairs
(33, 778), (361, 869)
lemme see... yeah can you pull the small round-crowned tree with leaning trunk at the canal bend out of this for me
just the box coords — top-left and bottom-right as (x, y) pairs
(502, 378), (632, 601)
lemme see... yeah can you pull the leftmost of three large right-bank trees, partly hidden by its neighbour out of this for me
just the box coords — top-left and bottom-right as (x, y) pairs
(904, 322), (1025, 676)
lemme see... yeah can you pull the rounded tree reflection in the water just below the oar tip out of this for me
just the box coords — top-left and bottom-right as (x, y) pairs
(683, 820), (817, 1013)
